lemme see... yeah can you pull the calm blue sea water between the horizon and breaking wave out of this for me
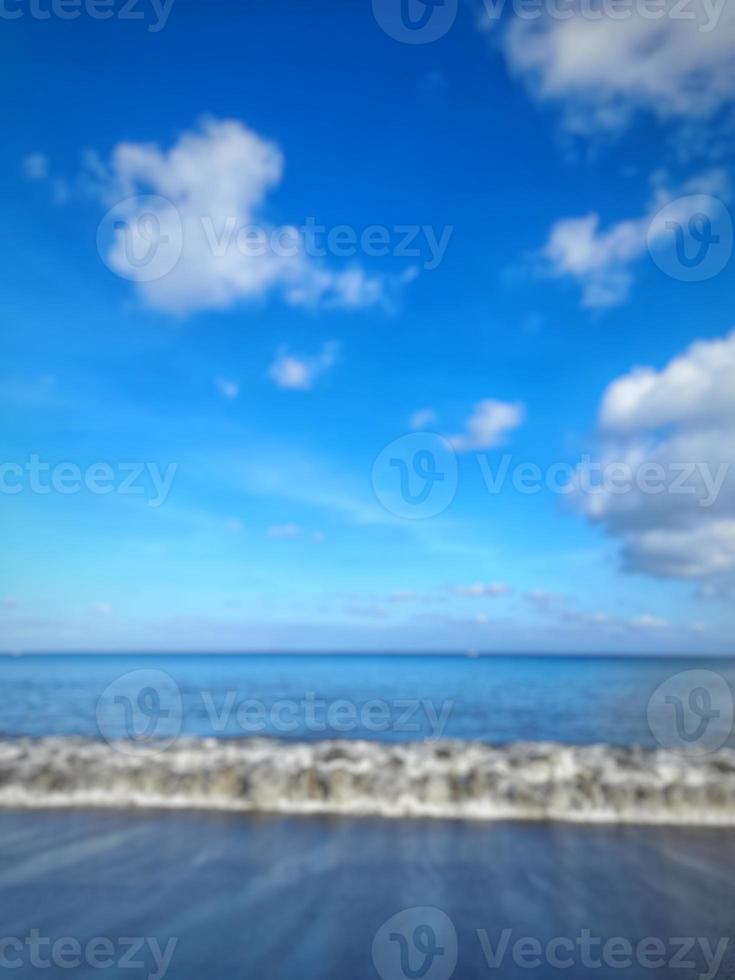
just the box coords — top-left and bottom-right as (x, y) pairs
(0, 655), (735, 748)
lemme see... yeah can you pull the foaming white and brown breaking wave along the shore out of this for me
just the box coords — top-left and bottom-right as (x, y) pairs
(0, 737), (735, 826)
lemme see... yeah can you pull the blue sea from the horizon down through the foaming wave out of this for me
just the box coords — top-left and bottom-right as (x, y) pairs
(0, 655), (735, 826)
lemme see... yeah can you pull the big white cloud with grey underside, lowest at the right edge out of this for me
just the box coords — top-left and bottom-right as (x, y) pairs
(576, 331), (735, 595)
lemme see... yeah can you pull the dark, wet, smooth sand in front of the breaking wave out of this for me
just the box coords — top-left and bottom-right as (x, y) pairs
(0, 810), (735, 980)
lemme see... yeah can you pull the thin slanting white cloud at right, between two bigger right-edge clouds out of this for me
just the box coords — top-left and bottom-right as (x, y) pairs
(540, 170), (729, 309)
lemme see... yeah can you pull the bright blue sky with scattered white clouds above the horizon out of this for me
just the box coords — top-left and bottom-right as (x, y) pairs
(0, 0), (735, 652)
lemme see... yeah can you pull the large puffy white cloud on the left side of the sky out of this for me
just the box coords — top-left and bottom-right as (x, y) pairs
(94, 119), (383, 315)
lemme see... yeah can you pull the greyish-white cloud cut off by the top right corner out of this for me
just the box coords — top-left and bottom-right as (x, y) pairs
(501, 0), (735, 132)
